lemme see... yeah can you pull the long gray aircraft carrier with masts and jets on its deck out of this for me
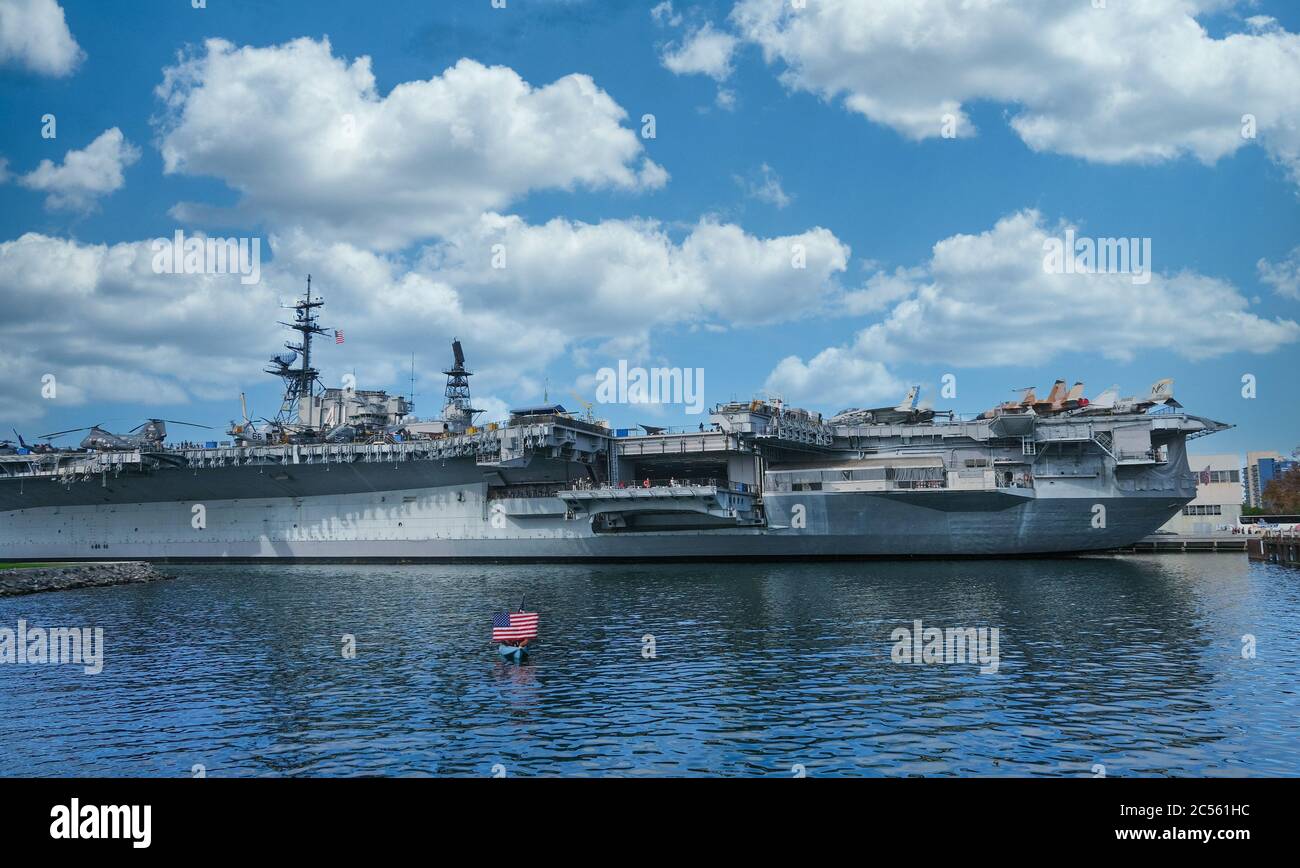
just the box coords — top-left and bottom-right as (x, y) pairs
(0, 282), (1229, 561)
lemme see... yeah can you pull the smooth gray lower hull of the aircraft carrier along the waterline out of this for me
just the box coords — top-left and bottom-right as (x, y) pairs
(0, 485), (1186, 561)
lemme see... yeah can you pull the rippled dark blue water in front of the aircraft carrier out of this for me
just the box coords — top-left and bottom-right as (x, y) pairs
(0, 555), (1300, 776)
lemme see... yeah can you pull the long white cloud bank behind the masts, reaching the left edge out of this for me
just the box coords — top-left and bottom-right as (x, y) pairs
(0, 214), (849, 421)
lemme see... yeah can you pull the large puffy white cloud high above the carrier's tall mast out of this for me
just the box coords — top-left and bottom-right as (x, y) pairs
(157, 39), (667, 248)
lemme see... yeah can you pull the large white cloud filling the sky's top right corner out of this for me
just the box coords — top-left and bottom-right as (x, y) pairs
(732, 0), (1300, 182)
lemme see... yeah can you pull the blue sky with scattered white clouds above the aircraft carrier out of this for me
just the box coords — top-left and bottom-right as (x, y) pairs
(0, 0), (1300, 452)
